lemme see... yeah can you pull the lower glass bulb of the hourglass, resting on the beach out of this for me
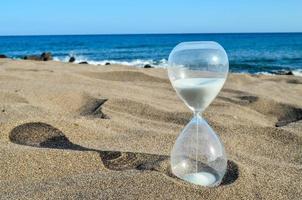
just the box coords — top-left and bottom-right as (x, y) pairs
(171, 114), (227, 187)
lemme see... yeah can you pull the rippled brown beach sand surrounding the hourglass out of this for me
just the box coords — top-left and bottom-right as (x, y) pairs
(0, 59), (302, 200)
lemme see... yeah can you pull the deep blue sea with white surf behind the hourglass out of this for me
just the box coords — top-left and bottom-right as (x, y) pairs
(0, 33), (302, 75)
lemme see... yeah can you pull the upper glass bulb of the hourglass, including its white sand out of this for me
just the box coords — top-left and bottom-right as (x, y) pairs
(168, 42), (229, 112)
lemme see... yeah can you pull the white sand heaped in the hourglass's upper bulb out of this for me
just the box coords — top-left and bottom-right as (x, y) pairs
(173, 78), (225, 110)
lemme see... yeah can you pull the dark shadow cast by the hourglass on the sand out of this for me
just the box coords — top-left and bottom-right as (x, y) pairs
(9, 122), (239, 185)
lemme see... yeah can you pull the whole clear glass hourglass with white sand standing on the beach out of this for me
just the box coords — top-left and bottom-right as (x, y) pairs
(168, 42), (229, 187)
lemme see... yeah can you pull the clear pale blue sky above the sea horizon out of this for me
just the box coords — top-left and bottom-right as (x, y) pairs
(0, 0), (302, 35)
